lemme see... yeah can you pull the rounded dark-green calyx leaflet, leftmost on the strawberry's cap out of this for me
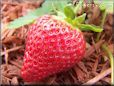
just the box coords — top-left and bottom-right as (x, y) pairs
(64, 6), (75, 19)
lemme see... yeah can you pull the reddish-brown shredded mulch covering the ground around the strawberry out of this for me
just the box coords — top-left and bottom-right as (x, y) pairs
(1, 0), (113, 85)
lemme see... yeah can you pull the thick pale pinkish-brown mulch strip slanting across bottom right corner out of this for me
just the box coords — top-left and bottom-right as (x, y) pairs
(83, 68), (111, 85)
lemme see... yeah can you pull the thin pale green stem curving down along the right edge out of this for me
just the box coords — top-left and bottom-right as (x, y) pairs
(102, 44), (114, 85)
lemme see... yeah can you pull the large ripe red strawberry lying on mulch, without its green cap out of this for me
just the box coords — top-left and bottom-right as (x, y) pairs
(21, 15), (86, 82)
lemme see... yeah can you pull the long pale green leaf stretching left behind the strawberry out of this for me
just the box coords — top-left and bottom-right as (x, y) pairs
(8, 0), (52, 29)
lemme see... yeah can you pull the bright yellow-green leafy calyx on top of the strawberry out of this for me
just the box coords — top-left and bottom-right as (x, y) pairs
(64, 1), (103, 32)
